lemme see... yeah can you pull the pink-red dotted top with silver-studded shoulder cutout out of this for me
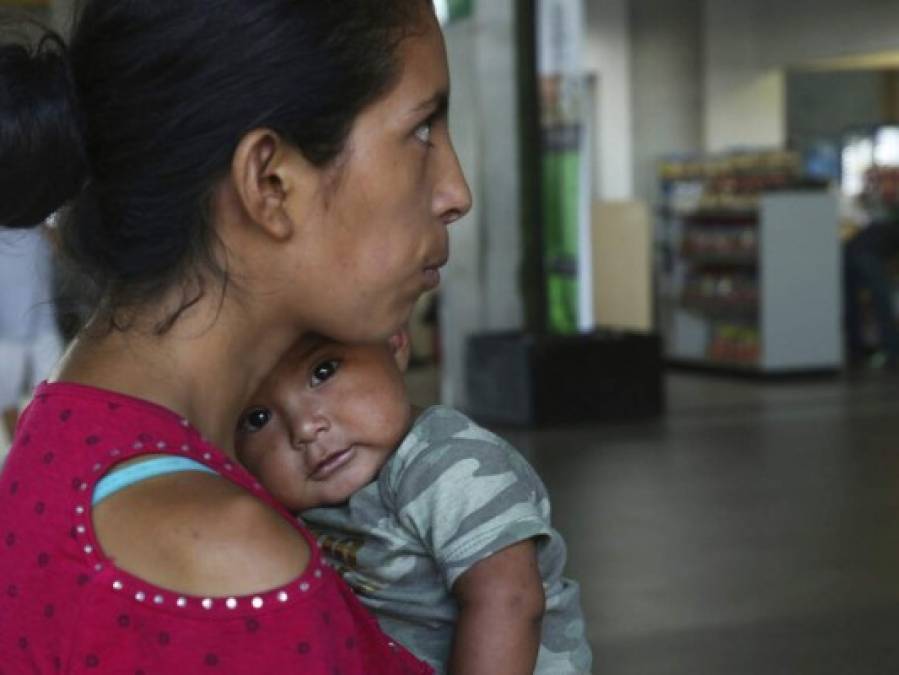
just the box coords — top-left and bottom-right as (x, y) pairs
(0, 384), (432, 675)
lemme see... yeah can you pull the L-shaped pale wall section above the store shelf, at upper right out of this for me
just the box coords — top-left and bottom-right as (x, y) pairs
(704, 0), (899, 151)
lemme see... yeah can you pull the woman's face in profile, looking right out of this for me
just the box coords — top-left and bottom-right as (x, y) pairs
(284, 17), (471, 342)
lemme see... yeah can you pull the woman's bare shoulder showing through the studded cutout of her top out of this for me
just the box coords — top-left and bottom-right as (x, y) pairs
(92, 472), (312, 597)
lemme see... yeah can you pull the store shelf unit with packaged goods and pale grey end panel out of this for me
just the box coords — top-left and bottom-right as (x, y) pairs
(660, 185), (843, 375)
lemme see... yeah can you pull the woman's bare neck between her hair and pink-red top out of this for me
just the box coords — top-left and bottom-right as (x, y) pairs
(54, 298), (302, 456)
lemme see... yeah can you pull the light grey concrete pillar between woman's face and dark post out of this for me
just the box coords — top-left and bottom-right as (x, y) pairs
(441, 0), (523, 408)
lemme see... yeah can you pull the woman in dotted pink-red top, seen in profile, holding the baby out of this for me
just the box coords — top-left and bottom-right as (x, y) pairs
(0, 0), (470, 674)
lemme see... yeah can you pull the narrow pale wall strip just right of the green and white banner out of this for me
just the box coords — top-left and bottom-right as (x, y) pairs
(584, 0), (634, 199)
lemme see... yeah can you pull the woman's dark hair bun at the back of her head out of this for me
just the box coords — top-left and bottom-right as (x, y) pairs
(0, 32), (88, 228)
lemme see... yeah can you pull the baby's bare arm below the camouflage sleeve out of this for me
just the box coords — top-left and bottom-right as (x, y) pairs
(448, 539), (545, 675)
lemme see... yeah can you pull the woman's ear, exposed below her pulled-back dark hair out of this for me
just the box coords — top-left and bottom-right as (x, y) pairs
(231, 129), (311, 240)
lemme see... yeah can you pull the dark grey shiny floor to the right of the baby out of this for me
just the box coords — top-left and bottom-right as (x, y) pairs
(486, 375), (899, 675)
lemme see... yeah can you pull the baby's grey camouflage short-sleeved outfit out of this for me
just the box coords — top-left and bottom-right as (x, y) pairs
(302, 406), (591, 675)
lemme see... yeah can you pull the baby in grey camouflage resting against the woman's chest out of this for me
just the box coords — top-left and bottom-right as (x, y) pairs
(237, 331), (591, 675)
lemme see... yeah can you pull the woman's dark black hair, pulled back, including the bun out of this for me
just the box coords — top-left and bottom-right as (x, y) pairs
(0, 0), (430, 330)
